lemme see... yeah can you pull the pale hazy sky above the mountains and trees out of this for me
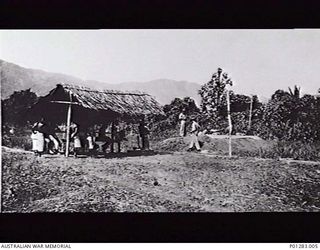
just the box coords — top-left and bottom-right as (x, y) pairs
(0, 30), (320, 97)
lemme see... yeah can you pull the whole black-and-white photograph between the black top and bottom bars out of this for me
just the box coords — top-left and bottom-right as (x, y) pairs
(0, 29), (320, 216)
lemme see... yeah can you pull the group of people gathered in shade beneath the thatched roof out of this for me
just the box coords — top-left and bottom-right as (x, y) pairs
(31, 118), (149, 157)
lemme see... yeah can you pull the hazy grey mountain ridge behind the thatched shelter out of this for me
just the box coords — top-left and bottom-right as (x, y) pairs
(0, 59), (200, 104)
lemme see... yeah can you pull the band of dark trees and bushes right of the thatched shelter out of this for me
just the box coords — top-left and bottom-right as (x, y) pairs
(149, 69), (320, 160)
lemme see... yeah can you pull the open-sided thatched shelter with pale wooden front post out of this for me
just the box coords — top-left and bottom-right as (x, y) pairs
(33, 83), (164, 155)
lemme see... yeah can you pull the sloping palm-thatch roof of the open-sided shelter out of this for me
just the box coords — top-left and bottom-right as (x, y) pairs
(44, 83), (164, 116)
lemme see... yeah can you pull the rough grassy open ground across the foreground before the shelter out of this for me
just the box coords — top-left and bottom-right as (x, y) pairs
(2, 136), (320, 212)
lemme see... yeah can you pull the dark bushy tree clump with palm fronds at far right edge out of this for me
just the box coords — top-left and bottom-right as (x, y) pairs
(259, 86), (320, 141)
